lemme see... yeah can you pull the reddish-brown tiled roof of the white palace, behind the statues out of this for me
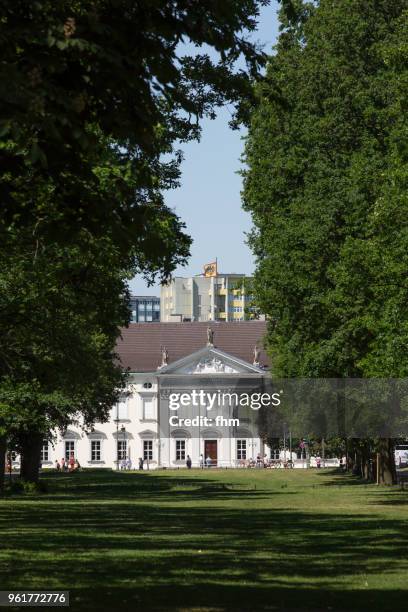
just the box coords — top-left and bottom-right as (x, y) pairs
(117, 321), (269, 372)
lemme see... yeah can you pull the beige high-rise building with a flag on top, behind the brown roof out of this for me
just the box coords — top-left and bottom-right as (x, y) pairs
(160, 273), (252, 323)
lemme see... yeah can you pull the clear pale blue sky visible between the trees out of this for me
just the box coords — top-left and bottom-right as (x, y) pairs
(130, 0), (278, 295)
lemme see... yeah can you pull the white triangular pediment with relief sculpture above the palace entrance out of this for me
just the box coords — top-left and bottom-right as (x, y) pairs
(158, 346), (264, 376)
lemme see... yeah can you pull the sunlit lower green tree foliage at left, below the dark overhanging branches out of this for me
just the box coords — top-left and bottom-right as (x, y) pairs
(0, 224), (129, 444)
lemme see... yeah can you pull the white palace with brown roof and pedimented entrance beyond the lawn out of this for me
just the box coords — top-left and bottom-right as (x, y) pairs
(42, 321), (269, 469)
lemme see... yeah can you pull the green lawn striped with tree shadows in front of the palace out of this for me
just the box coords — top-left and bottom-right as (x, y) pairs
(0, 470), (408, 611)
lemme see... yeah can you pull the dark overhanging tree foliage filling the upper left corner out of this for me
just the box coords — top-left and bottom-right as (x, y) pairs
(0, 0), (266, 280)
